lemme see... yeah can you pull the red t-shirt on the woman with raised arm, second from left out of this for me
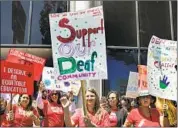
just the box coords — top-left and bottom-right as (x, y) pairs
(42, 101), (64, 127)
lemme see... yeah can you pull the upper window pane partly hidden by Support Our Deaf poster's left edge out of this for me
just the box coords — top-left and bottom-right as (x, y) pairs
(30, 1), (67, 45)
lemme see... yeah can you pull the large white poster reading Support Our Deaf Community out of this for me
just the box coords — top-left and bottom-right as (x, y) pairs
(49, 6), (107, 81)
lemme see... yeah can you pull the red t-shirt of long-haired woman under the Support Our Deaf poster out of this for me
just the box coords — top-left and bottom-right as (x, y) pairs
(71, 109), (110, 127)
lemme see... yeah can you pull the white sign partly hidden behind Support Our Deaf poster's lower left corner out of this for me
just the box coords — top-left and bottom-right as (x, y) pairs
(42, 67), (81, 96)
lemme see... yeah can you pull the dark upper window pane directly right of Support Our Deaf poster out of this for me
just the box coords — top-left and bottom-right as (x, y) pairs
(103, 1), (137, 46)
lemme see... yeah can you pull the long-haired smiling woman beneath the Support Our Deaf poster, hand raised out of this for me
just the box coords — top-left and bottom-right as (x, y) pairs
(61, 89), (110, 127)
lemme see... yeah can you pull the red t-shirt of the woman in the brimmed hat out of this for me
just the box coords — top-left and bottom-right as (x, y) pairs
(127, 108), (160, 127)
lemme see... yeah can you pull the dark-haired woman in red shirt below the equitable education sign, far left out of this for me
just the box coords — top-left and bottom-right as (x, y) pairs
(2, 94), (40, 127)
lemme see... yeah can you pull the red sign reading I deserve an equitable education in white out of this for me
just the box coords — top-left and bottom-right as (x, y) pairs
(0, 60), (34, 95)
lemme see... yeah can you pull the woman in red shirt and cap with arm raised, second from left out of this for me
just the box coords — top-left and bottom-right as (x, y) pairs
(36, 81), (64, 127)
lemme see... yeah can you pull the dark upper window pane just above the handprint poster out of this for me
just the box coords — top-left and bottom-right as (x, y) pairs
(138, 1), (171, 47)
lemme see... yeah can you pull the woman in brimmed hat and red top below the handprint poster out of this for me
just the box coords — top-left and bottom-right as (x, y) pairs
(124, 93), (169, 127)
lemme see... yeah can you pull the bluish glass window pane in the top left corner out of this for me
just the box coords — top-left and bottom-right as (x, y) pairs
(0, 0), (30, 44)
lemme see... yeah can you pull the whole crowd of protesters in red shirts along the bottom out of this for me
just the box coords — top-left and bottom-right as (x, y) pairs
(0, 82), (177, 127)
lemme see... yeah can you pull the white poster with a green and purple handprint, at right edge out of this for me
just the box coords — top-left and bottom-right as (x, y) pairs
(147, 36), (177, 101)
